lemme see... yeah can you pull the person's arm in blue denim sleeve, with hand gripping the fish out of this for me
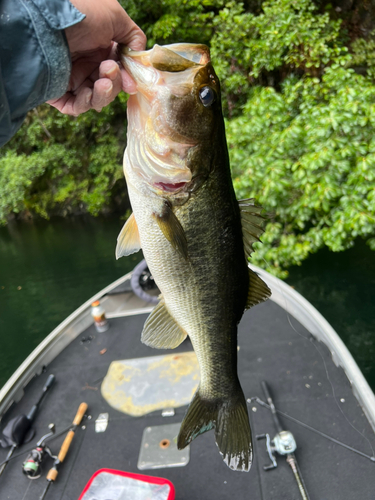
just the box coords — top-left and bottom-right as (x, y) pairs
(0, 0), (146, 146)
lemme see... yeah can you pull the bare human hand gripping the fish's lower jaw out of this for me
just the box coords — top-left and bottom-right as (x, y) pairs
(47, 0), (146, 116)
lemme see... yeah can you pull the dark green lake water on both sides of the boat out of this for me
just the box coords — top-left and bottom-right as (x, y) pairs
(0, 217), (375, 390)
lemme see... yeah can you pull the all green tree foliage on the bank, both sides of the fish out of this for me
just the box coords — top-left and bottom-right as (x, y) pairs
(0, 0), (375, 276)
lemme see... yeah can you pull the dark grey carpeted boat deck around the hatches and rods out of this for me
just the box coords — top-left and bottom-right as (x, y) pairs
(0, 291), (375, 500)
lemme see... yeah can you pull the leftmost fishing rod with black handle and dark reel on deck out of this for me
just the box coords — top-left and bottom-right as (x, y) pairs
(0, 374), (55, 476)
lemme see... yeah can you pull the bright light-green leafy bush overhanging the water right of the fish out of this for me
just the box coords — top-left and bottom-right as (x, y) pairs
(228, 66), (375, 275)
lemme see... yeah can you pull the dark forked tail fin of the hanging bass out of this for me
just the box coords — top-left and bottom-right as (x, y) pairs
(177, 388), (253, 471)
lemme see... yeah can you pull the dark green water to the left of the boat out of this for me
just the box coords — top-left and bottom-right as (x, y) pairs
(0, 217), (141, 387)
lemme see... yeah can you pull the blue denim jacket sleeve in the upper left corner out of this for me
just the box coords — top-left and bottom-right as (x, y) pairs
(0, 0), (85, 146)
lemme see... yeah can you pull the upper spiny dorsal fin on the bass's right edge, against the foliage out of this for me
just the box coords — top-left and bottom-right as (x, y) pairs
(238, 198), (266, 259)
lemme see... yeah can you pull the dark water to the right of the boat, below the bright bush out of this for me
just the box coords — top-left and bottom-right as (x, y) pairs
(287, 240), (375, 391)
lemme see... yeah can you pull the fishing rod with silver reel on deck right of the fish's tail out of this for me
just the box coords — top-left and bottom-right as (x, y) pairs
(256, 380), (310, 500)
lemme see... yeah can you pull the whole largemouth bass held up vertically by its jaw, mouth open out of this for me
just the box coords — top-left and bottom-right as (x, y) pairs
(116, 44), (270, 471)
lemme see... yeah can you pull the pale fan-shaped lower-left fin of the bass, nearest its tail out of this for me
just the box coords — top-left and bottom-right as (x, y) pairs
(141, 299), (187, 349)
